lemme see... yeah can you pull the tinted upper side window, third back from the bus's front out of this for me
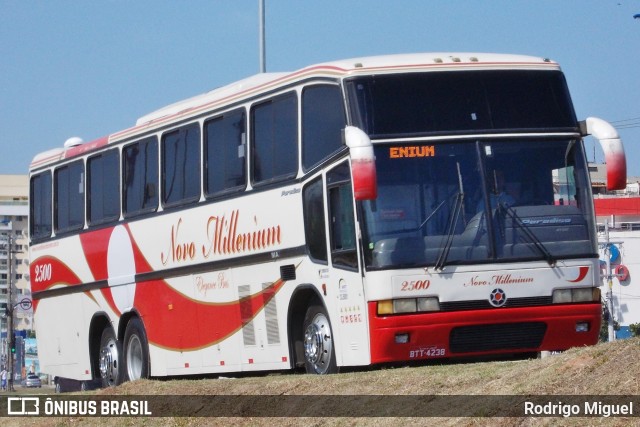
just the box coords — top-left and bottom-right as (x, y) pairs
(204, 110), (247, 196)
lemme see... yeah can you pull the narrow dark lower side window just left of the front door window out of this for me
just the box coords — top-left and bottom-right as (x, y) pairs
(302, 178), (327, 263)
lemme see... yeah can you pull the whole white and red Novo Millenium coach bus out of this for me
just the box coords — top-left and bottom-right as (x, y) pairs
(30, 53), (626, 384)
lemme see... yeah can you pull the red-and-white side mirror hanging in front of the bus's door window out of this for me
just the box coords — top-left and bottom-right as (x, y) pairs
(344, 126), (378, 200)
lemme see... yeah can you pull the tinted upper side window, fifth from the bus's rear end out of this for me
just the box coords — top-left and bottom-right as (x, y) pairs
(162, 123), (200, 206)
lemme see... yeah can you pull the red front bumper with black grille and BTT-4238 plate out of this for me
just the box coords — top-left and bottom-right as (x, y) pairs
(368, 302), (602, 363)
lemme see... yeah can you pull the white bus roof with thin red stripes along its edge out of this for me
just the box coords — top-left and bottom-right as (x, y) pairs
(31, 52), (560, 169)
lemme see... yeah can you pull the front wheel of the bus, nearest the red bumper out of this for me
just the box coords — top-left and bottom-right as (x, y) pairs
(302, 304), (338, 375)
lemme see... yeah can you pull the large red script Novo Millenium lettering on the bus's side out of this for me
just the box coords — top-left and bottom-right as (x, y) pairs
(160, 210), (282, 265)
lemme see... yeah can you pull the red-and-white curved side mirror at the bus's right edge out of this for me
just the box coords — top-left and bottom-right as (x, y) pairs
(580, 117), (627, 190)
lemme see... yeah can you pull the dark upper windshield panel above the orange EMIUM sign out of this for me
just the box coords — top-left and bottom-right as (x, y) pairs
(346, 70), (577, 139)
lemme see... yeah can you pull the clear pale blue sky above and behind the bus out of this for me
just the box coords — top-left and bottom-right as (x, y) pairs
(0, 0), (640, 176)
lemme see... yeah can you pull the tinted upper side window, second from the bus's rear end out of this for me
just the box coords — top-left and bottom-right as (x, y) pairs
(54, 160), (84, 233)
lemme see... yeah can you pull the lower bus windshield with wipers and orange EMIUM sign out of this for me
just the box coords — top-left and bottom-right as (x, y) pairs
(362, 137), (597, 269)
